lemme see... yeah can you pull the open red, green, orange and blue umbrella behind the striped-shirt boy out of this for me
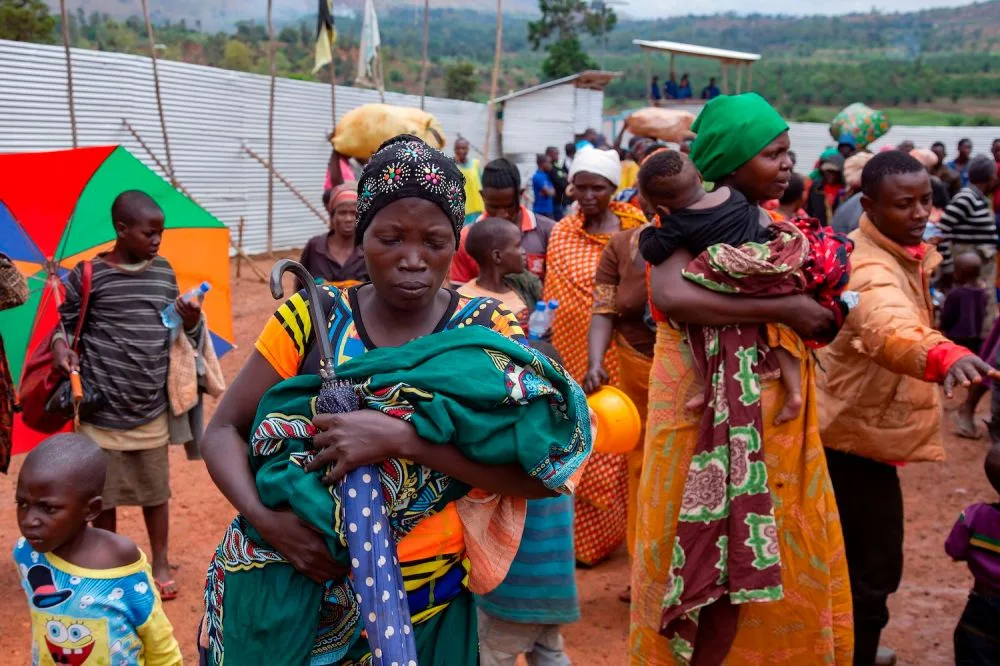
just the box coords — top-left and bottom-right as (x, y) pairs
(0, 146), (233, 453)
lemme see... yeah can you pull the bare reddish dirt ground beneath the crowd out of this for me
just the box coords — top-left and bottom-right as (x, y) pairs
(0, 253), (995, 666)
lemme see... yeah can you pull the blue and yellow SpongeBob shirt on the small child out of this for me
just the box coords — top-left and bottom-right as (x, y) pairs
(14, 538), (182, 666)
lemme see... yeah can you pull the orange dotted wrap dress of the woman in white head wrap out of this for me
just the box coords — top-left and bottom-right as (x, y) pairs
(545, 202), (646, 565)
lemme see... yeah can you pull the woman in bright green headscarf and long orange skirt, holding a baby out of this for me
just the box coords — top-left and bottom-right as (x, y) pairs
(629, 93), (853, 666)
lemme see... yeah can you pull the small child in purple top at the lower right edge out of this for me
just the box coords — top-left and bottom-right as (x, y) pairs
(944, 440), (1000, 664)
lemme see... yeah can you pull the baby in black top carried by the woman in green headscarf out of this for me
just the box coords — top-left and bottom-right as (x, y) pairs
(639, 150), (832, 425)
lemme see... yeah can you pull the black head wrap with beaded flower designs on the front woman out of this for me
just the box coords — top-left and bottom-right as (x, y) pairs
(355, 134), (465, 247)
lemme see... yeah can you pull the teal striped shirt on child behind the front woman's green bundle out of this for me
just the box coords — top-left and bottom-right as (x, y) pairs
(476, 495), (580, 624)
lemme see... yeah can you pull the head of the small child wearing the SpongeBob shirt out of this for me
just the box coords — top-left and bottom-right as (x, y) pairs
(15, 433), (108, 553)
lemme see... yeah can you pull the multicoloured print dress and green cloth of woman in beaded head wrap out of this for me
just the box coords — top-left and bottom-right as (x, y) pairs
(203, 288), (589, 666)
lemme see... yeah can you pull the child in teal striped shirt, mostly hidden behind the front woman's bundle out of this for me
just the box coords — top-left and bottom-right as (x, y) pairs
(476, 339), (580, 666)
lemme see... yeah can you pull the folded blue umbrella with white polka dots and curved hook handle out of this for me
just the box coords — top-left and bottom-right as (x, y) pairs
(271, 259), (417, 666)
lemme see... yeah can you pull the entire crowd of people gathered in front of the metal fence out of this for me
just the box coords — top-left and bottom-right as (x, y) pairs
(0, 92), (1000, 666)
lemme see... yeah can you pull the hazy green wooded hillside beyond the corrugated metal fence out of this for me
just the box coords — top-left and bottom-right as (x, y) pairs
(31, 0), (1000, 124)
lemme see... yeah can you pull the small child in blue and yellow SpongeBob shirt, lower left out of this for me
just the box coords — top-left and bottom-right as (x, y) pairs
(14, 434), (182, 666)
